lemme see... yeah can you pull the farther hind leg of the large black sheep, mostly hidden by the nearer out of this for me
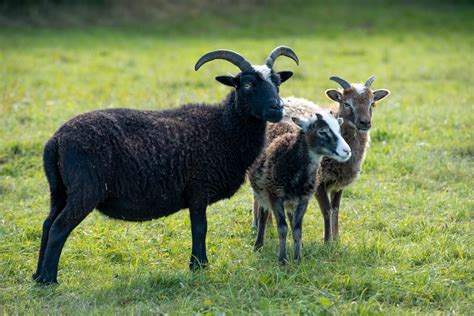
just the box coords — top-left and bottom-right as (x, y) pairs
(33, 189), (67, 280)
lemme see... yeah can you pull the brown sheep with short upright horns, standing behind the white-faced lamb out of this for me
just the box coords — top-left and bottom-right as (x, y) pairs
(278, 76), (390, 241)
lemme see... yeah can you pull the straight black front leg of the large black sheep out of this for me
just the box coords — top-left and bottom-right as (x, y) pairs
(189, 206), (207, 271)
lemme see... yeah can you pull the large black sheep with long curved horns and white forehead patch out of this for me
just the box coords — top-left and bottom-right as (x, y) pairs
(33, 46), (298, 284)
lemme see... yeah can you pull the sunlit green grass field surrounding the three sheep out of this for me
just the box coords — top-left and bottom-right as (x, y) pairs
(0, 1), (474, 314)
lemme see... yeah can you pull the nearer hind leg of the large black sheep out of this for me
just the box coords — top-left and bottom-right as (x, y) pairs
(35, 198), (94, 284)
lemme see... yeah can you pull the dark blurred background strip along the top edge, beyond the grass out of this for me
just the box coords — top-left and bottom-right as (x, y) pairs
(0, 0), (474, 27)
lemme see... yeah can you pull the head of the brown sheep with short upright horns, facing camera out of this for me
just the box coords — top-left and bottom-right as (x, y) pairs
(326, 76), (390, 133)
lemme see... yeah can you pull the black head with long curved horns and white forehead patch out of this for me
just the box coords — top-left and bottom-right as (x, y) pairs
(194, 46), (299, 122)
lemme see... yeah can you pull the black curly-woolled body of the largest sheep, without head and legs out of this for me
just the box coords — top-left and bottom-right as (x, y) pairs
(44, 92), (266, 221)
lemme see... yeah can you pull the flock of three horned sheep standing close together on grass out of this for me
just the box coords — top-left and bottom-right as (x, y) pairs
(33, 46), (390, 284)
